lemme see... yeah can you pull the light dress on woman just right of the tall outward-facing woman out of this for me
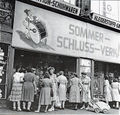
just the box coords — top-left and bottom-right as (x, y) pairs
(57, 75), (67, 101)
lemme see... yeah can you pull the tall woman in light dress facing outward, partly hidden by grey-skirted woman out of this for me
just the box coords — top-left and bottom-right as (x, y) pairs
(48, 67), (57, 111)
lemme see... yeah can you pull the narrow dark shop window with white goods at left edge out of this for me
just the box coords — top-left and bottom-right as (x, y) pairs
(0, 43), (8, 99)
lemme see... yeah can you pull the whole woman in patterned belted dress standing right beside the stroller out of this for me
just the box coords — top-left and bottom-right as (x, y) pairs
(81, 72), (91, 110)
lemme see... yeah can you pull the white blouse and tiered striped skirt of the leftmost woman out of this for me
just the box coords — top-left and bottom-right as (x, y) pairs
(9, 72), (24, 101)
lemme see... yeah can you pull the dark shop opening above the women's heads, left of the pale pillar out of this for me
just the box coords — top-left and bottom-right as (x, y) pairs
(14, 49), (76, 73)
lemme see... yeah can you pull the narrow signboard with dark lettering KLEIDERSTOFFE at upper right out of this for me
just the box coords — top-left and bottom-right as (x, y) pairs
(91, 13), (120, 30)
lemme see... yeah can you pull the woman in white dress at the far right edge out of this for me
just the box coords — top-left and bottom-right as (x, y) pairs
(111, 78), (120, 109)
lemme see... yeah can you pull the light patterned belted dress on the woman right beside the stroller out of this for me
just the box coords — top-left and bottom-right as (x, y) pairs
(81, 76), (91, 102)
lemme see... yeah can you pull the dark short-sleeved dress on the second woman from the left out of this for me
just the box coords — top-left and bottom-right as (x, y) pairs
(22, 72), (36, 102)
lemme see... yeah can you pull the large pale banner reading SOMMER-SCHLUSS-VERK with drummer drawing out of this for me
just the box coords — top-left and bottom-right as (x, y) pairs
(12, 1), (120, 63)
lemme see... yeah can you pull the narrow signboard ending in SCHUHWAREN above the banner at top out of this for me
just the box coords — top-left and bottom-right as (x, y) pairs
(30, 0), (80, 16)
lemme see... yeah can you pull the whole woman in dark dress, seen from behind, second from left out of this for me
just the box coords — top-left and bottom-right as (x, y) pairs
(22, 68), (36, 111)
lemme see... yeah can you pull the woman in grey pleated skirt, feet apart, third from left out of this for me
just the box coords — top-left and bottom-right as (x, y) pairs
(35, 72), (53, 112)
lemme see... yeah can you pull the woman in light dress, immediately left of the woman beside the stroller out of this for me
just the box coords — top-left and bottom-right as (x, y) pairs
(69, 73), (82, 110)
